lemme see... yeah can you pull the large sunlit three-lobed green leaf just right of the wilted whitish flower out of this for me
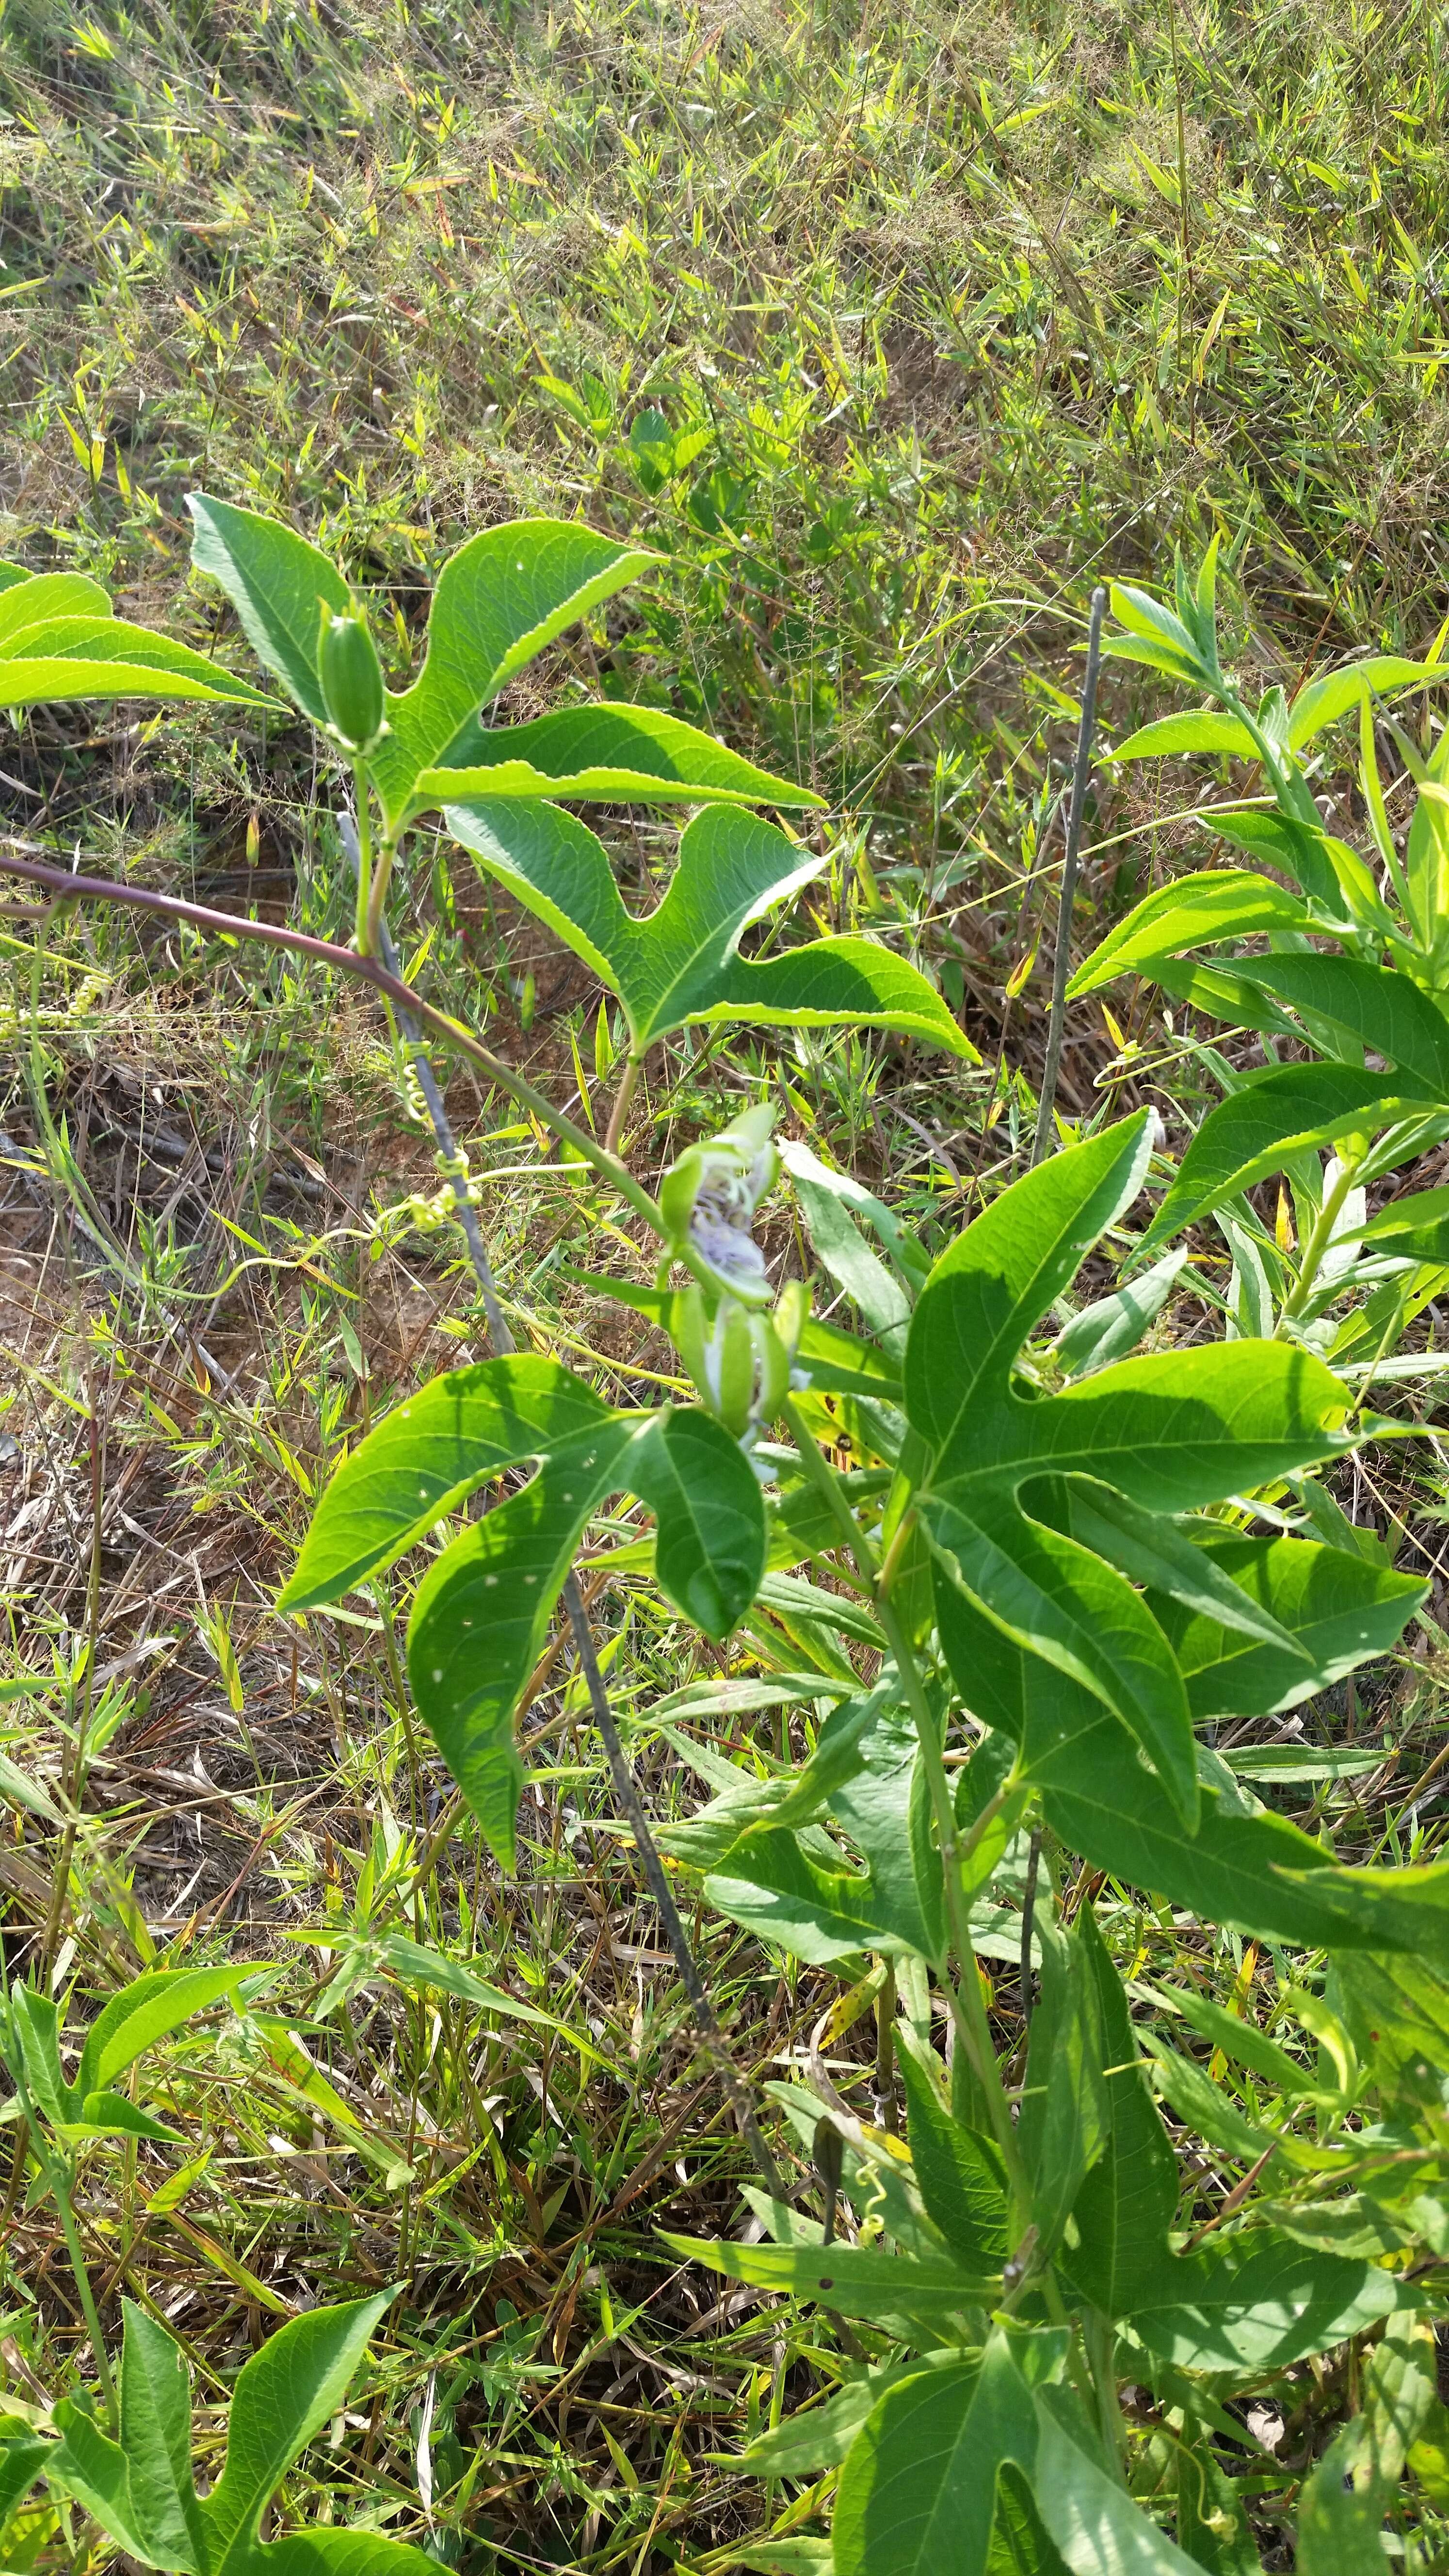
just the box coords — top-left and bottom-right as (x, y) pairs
(905, 1113), (1351, 1829)
